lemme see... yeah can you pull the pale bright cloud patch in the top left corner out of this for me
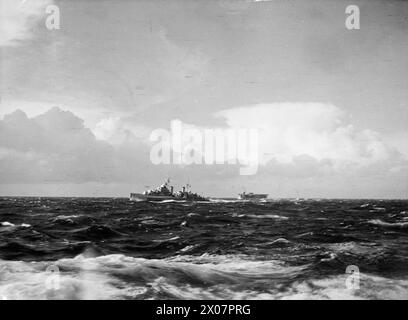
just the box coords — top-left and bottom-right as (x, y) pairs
(0, 0), (53, 46)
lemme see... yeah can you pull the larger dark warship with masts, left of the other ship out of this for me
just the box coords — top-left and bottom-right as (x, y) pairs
(130, 179), (209, 201)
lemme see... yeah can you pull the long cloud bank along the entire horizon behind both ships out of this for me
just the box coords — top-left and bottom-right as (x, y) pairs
(0, 107), (408, 197)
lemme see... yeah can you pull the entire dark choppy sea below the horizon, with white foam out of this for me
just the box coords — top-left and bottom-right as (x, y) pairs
(0, 197), (408, 299)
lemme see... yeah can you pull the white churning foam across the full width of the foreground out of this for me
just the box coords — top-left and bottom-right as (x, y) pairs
(0, 255), (408, 299)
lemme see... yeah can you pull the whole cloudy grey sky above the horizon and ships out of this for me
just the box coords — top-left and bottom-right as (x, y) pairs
(0, 0), (408, 198)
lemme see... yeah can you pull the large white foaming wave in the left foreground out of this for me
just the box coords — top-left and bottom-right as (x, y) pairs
(0, 255), (303, 299)
